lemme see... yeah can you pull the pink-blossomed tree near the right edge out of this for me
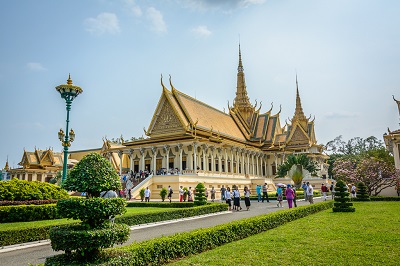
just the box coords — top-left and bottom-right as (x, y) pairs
(333, 156), (400, 196)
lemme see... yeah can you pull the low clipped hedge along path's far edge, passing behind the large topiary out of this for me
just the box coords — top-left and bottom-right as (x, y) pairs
(0, 203), (228, 246)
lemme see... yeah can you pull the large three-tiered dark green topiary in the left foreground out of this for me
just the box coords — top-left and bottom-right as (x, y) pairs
(46, 153), (129, 261)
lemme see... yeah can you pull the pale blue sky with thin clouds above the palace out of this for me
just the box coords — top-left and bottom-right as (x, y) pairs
(0, 0), (400, 167)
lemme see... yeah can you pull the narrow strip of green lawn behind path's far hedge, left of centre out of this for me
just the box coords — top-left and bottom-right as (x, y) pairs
(0, 207), (173, 231)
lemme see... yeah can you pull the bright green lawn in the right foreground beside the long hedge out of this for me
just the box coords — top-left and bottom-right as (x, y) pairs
(172, 202), (400, 265)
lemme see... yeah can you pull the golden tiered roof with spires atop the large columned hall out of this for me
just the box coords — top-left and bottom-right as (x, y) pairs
(141, 45), (316, 150)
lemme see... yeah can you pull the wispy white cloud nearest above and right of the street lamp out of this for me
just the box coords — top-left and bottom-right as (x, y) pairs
(84, 12), (120, 35)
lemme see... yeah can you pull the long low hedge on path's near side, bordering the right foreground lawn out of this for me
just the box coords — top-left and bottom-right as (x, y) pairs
(45, 201), (333, 266)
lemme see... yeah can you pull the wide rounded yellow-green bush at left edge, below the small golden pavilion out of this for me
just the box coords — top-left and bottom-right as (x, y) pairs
(0, 178), (69, 201)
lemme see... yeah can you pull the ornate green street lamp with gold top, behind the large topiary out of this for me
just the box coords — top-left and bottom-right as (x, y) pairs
(56, 75), (83, 182)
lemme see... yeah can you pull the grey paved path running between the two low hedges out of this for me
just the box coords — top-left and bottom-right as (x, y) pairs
(0, 198), (328, 266)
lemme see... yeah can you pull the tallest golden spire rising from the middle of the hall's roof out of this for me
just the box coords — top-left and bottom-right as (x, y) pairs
(233, 43), (254, 123)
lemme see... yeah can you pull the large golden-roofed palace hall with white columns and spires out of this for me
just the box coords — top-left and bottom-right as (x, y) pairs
(70, 46), (328, 196)
